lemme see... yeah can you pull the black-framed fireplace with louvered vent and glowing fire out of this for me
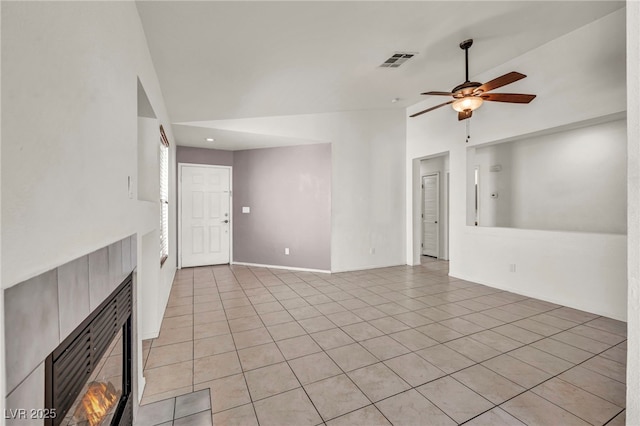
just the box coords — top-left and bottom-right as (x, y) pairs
(45, 274), (133, 426)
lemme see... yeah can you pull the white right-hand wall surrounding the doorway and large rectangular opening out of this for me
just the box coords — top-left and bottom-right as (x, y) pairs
(407, 10), (626, 319)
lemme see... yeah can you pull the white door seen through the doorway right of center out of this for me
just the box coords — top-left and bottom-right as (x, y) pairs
(422, 173), (440, 257)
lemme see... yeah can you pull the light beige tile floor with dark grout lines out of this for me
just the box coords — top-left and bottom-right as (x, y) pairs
(138, 259), (626, 426)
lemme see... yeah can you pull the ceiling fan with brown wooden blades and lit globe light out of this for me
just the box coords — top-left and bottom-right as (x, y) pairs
(411, 39), (536, 120)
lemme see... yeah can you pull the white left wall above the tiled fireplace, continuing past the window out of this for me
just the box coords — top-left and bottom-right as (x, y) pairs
(1, 2), (176, 410)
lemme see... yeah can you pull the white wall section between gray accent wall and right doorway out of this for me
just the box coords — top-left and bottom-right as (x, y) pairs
(182, 110), (405, 272)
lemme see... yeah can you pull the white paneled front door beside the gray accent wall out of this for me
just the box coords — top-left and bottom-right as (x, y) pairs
(180, 165), (231, 267)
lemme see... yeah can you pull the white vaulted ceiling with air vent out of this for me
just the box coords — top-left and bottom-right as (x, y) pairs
(137, 0), (624, 150)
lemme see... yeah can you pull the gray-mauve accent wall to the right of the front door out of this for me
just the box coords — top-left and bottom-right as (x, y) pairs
(233, 143), (331, 270)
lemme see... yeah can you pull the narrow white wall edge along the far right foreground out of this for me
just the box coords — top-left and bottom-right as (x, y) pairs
(627, 1), (640, 425)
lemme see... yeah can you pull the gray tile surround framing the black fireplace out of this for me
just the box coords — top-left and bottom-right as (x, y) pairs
(4, 235), (137, 426)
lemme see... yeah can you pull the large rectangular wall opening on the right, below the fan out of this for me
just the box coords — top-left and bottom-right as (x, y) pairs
(467, 117), (627, 234)
